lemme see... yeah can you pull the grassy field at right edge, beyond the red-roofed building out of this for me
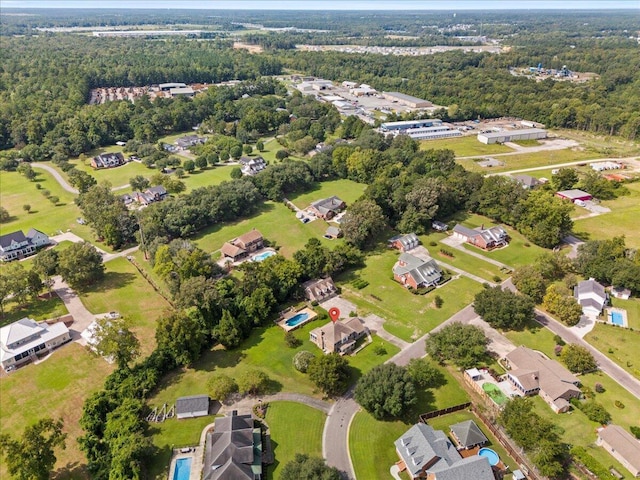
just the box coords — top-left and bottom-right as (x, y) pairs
(573, 183), (640, 248)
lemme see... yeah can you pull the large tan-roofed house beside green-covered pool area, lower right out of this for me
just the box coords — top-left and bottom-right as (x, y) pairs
(505, 347), (580, 413)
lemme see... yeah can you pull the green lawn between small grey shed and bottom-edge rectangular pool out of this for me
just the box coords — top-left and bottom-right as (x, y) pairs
(148, 416), (215, 480)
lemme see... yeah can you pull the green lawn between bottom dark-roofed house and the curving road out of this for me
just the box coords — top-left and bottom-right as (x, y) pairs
(265, 402), (326, 480)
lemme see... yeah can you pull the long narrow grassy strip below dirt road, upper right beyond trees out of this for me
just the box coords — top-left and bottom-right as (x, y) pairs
(457, 149), (602, 173)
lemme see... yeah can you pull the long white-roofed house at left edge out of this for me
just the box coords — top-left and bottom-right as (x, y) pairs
(0, 317), (71, 371)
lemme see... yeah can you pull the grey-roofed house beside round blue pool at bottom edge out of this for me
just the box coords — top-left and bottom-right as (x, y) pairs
(394, 423), (495, 480)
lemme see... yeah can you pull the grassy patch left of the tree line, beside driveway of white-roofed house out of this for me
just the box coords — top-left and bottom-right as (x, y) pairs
(80, 258), (170, 356)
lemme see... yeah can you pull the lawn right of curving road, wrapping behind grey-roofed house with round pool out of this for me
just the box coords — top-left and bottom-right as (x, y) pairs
(349, 369), (468, 480)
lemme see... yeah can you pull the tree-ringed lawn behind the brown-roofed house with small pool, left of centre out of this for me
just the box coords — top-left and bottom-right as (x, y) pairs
(193, 202), (330, 258)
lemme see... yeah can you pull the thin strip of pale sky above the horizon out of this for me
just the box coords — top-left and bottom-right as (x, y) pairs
(0, 0), (640, 11)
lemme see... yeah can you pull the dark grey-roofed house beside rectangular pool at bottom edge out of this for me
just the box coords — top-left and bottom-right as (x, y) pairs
(202, 411), (262, 480)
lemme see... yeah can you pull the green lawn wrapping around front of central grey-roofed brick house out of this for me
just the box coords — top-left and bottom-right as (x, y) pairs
(338, 250), (482, 341)
